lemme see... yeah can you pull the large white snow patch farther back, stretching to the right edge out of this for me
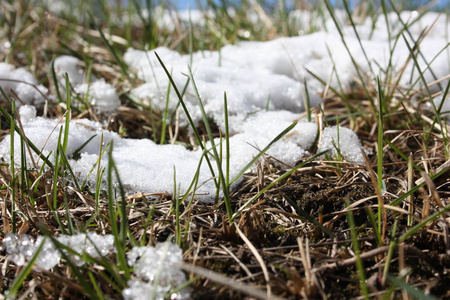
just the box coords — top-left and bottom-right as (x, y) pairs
(124, 12), (450, 124)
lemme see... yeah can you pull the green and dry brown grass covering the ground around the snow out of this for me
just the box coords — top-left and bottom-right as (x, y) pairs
(0, 0), (450, 299)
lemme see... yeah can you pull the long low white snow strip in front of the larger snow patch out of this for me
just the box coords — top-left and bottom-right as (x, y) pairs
(0, 107), (317, 201)
